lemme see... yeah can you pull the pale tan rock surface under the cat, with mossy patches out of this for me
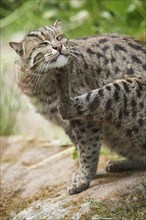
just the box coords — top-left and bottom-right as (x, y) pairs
(1, 137), (146, 220)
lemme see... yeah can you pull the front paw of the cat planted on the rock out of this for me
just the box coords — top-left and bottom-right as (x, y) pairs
(67, 174), (90, 195)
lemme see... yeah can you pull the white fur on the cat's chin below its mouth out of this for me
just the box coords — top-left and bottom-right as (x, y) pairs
(48, 55), (68, 69)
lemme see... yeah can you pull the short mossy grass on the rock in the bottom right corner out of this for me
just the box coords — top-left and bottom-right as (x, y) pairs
(84, 193), (146, 220)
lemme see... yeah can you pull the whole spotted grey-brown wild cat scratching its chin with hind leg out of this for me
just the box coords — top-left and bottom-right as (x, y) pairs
(10, 22), (146, 194)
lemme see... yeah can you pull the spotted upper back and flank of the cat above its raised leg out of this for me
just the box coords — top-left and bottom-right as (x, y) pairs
(71, 33), (146, 82)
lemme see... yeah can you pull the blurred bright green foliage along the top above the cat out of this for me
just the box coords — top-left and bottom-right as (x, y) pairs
(0, 0), (146, 38)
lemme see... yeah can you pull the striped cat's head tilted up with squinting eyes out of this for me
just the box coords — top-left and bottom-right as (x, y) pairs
(10, 21), (70, 73)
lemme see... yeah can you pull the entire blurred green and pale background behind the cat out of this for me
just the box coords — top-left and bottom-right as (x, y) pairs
(0, 0), (146, 139)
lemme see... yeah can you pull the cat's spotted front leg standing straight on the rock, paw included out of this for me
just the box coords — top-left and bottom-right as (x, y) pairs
(68, 121), (102, 195)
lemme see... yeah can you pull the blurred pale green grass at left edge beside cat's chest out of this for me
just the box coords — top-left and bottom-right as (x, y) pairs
(0, 55), (21, 135)
